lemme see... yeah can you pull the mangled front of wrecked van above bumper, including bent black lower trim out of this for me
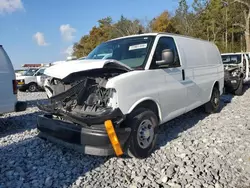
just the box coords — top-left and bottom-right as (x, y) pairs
(38, 77), (124, 126)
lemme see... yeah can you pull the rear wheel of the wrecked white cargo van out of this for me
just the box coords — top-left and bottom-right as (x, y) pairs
(205, 87), (220, 114)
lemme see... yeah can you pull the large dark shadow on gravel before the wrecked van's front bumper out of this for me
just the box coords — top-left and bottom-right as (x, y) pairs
(0, 137), (108, 187)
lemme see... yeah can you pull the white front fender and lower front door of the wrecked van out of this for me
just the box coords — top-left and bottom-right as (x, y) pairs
(106, 69), (188, 123)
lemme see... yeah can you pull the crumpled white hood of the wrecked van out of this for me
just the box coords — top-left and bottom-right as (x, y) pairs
(44, 59), (133, 79)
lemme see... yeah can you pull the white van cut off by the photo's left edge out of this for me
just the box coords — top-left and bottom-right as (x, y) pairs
(0, 45), (27, 114)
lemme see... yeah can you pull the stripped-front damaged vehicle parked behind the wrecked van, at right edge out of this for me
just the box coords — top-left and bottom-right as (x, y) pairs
(221, 53), (249, 95)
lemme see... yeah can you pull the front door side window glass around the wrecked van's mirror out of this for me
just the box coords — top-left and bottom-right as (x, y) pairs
(150, 37), (181, 69)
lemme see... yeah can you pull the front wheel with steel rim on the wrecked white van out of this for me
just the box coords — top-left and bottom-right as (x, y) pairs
(126, 108), (158, 159)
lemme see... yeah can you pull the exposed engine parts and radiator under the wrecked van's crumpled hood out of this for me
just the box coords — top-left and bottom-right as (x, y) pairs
(38, 77), (121, 123)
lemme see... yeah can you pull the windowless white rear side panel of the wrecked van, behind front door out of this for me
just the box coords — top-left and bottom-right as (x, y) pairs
(175, 36), (224, 112)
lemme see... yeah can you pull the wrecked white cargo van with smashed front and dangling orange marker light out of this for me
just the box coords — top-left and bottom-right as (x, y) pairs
(37, 33), (224, 158)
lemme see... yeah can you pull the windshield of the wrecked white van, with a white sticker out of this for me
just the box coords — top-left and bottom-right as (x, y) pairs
(86, 36), (154, 68)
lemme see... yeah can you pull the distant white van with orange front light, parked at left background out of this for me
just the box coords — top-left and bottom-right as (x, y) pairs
(16, 67), (47, 92)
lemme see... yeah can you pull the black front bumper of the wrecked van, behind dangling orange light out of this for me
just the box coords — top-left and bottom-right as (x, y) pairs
(37, 115), (131, 156)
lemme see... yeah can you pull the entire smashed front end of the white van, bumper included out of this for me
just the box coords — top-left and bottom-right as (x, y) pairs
(37, 64), (131, 156)
